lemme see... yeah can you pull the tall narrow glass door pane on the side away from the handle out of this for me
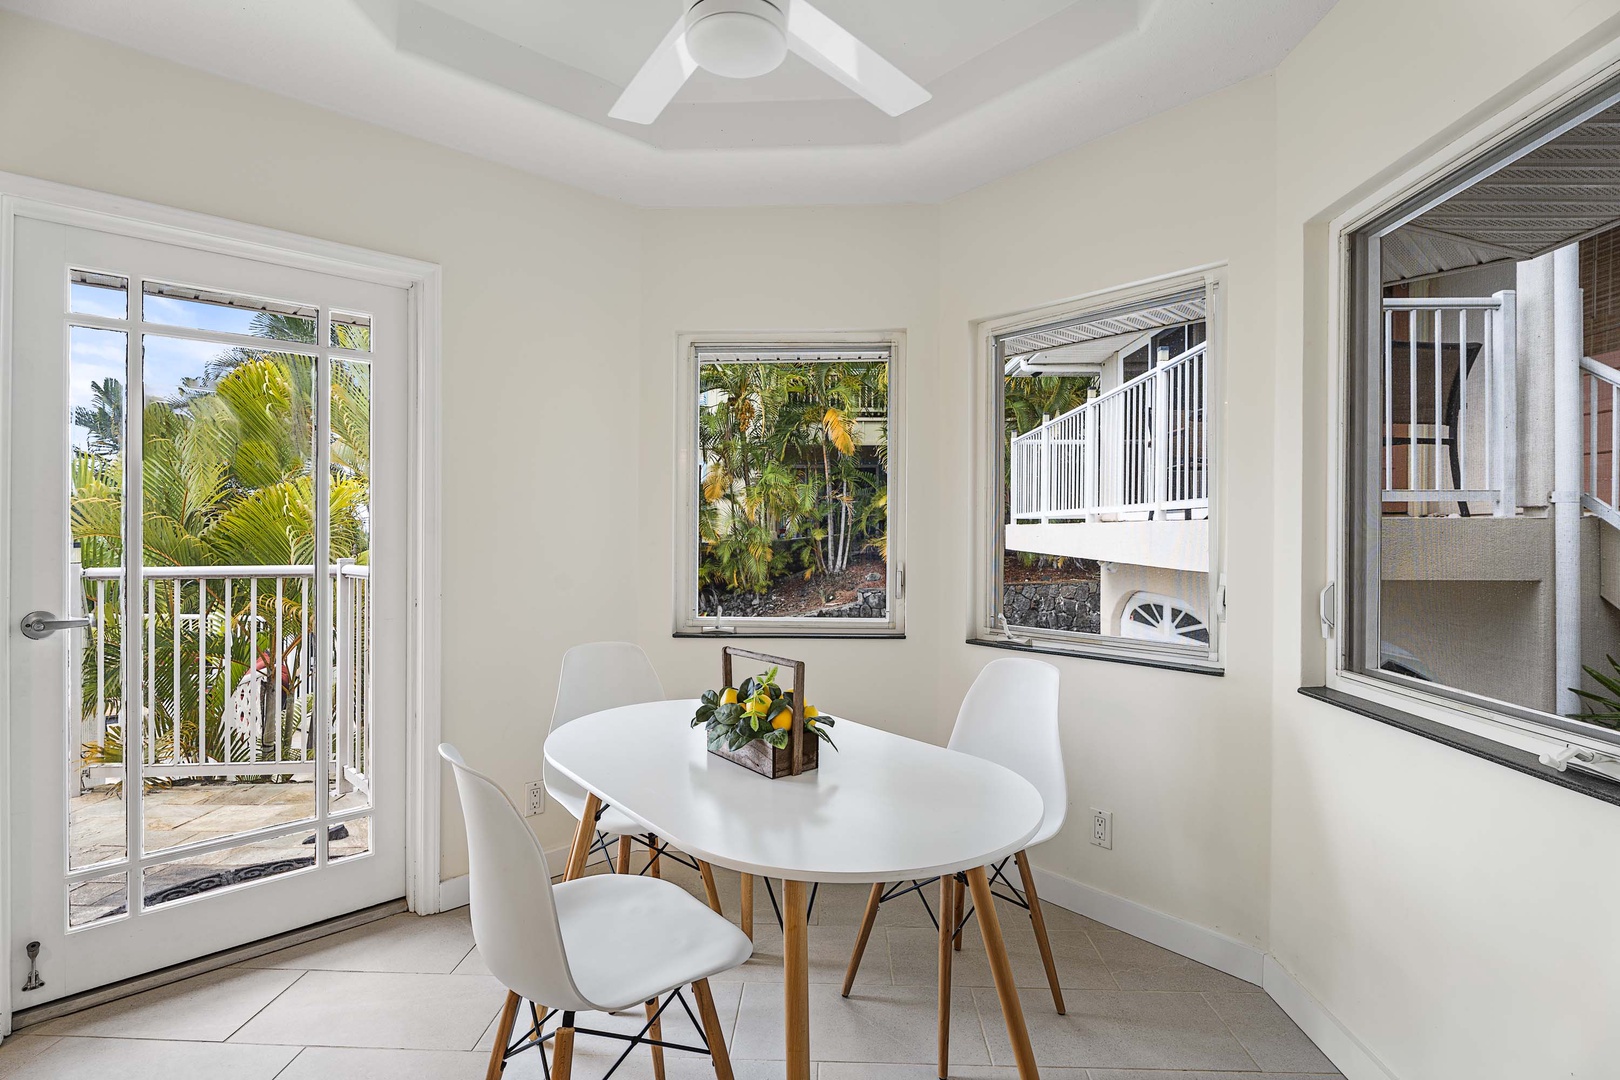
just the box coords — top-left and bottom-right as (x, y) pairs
(330, 359), (371, 816)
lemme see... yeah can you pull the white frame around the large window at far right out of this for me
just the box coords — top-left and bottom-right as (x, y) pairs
(1321, 40), (1620, 753)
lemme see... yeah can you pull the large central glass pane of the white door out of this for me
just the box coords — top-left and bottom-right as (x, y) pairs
(143, 334), (314, 848)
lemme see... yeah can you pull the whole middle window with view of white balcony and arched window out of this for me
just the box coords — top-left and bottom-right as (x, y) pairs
(975, 272), (1225, 670)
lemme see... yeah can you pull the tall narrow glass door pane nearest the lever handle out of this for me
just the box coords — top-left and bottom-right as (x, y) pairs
(68, 327), (128, 867)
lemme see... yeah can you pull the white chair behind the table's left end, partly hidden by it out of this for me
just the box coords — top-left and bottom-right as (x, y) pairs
(541, 641), (674, 878)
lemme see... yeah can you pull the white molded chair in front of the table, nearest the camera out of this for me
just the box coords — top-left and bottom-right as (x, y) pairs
(439, 743), (753, 1080)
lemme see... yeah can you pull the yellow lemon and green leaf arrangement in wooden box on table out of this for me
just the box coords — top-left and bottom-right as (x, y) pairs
(692, 667), (838, 777)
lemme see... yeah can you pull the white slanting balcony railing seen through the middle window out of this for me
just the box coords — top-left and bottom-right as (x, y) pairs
(1009, 345), (1210, 521)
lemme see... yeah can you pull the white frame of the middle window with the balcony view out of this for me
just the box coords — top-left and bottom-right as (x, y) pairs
(967, 262), (1226, 675)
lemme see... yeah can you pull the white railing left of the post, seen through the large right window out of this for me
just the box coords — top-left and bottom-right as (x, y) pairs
(1382, 291), (1518, 517)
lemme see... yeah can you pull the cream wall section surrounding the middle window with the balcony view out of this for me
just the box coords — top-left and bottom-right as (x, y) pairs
(936, 78), (1275, 944)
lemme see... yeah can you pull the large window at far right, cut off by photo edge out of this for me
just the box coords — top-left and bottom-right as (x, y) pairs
(1325, 76), (1620, 761)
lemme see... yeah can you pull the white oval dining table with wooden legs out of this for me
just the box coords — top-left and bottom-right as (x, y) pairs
(544, 699), (1042, 1080)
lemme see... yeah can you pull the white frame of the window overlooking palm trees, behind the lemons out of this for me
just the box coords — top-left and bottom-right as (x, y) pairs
(671, 330), (907, 638)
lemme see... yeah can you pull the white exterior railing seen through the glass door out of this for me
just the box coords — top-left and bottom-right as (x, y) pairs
(70, 559), (371, 792)
